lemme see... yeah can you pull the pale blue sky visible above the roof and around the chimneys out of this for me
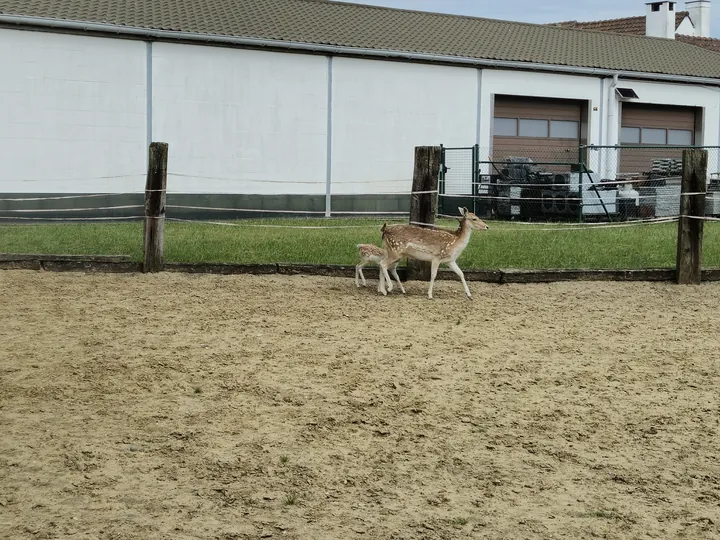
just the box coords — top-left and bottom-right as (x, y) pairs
(340, 0), (720, 38)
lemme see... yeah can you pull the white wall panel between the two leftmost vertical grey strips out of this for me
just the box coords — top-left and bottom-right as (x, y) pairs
(153, 43), (328, 194)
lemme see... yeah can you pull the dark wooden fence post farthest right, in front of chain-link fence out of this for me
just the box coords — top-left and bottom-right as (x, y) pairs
(676, 148), (708, 285)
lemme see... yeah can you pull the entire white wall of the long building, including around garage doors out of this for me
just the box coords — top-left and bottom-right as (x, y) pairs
(0, 25), (720, 198)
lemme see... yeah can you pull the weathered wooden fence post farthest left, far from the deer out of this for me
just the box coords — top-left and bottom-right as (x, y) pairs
(143, 142), (168, 272)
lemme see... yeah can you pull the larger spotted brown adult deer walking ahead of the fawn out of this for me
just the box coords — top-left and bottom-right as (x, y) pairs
(378, 207), (489, 300)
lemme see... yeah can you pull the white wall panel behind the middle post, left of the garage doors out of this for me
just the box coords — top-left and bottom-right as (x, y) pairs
(332, 58), (478, 194)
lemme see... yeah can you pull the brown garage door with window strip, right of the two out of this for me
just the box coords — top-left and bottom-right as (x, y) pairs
(618, 103), (696, 174)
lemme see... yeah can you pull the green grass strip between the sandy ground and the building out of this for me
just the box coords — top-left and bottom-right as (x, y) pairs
(0, 219), (720, 269)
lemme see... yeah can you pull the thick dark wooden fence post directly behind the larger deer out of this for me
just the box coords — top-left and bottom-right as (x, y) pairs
(407, 146), (442, 281)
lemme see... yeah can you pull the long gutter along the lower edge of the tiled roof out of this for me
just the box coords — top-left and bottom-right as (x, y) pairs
(0, 14), (720, 86)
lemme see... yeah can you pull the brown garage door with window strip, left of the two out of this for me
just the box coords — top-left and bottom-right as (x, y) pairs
(492, 96), (584, 162)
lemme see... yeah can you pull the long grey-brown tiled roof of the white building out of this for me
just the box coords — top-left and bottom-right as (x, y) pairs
(0, 0), (720, 78)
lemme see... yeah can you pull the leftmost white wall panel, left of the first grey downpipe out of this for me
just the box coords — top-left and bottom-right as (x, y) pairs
(0, 29), (147, 193)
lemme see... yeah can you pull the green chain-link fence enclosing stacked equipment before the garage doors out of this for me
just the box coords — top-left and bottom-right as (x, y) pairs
(438, 146), (720, 222)
